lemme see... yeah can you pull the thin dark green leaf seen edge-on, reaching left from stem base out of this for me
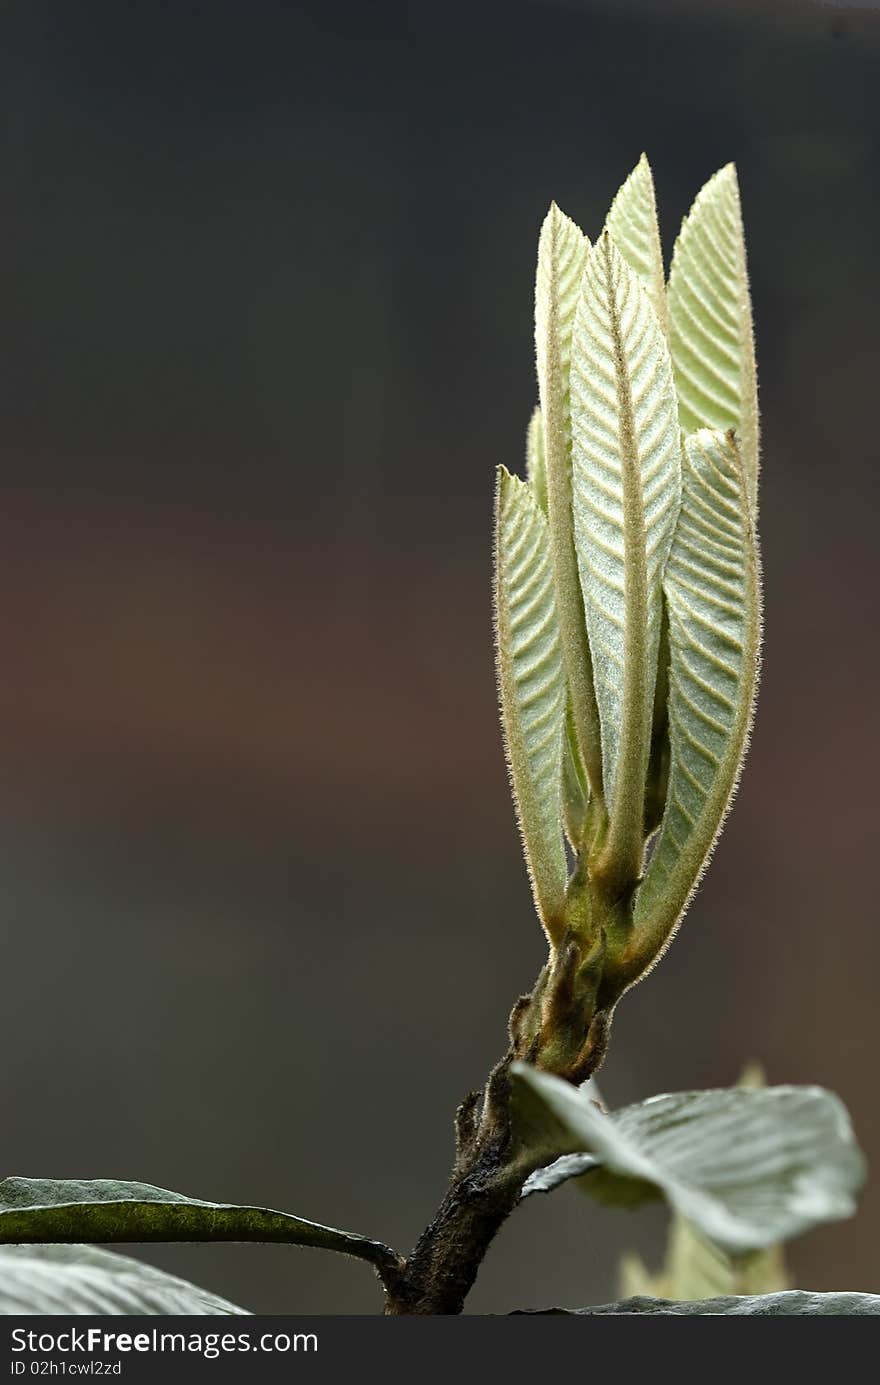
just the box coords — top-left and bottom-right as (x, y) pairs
(0, 1177), (396, 1269)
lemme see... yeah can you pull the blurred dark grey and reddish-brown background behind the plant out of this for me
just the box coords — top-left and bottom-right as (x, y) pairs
(0, 0), (880, 1313)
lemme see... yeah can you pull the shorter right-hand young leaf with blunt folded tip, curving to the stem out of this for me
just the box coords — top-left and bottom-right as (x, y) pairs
(635, 431), (761, 971)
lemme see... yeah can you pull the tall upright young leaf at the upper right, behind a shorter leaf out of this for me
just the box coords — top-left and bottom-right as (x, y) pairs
(668, 163), (759, 507)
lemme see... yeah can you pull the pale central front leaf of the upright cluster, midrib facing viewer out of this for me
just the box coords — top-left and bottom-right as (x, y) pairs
(571, 233), (680, 873)
